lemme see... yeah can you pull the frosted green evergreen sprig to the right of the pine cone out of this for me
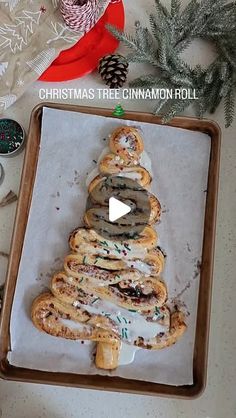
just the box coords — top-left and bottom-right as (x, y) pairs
(108, 0), (236, 127)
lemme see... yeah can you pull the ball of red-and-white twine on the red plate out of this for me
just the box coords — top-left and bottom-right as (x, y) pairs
(60, 0), (99, 32)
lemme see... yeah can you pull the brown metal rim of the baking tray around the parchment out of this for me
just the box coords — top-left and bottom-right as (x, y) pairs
(0, 103), (220, 398)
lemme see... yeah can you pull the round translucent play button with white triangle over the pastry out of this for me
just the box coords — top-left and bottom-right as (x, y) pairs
(84, 176), (153, 240)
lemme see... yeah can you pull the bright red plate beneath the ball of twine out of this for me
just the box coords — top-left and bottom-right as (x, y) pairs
(39, 1), (125, 81)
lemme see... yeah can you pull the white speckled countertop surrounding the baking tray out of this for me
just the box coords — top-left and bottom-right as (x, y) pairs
(0, 0), (236, 418)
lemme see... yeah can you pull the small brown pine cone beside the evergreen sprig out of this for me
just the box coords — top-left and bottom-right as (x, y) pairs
(98, 54), (129, 89)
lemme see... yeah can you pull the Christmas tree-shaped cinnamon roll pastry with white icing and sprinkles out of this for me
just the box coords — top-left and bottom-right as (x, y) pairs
(31, 126), (186, 370)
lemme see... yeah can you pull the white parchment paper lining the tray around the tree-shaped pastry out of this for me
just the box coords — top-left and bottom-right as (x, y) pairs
(8, 108), (211, 385)
